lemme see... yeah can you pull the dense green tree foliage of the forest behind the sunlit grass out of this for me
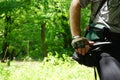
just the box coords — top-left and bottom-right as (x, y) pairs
(0, 0), (89, 59)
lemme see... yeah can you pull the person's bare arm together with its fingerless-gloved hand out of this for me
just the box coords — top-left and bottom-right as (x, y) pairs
(70, 0), (94, 55)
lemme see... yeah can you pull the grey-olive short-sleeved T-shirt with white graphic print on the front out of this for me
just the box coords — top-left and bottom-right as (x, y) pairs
(80, 0), (120, 33)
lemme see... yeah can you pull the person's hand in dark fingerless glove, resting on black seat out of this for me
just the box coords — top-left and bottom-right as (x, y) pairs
(72, 37), (94, 55)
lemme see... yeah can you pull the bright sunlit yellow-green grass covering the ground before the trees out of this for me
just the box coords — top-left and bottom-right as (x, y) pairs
(0, 57), (98, 80)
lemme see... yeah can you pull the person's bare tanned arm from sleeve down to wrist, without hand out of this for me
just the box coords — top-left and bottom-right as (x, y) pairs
(70, 0), (81, 36)
